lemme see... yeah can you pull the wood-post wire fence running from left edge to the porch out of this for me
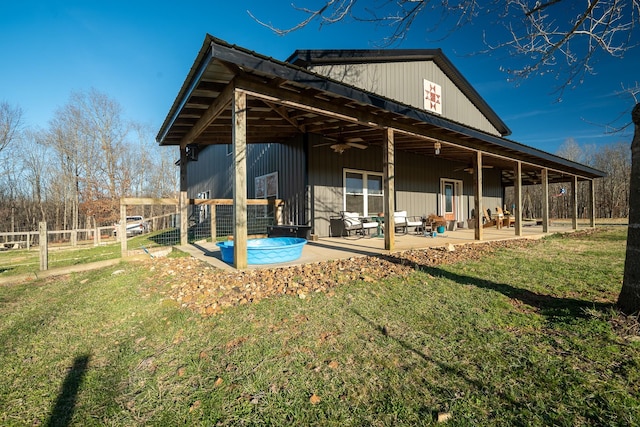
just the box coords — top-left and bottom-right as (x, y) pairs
(0, 199), (282, 277)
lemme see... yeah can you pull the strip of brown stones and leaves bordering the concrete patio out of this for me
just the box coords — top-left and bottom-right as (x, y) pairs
(145, 239), (538, 316)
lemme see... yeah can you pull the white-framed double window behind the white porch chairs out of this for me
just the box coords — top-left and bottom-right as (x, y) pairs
(342, 169), (384, 216)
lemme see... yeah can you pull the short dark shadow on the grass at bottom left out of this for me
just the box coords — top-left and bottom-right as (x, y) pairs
(46, 354), (89, 427)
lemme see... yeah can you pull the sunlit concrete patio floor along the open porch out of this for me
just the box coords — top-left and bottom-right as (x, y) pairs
(178, 223), (584, 269)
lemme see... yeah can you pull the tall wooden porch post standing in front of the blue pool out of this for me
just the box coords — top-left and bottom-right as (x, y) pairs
(232, 89), (248, 270)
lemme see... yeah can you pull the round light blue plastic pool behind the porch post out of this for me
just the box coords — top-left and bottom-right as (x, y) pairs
(216, 237), (307, 264)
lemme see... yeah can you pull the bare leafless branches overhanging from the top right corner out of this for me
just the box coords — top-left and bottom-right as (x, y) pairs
(248, 0), (640, 89)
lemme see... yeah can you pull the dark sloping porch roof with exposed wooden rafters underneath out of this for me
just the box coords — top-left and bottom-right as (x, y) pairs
(157, 35), (604, 182)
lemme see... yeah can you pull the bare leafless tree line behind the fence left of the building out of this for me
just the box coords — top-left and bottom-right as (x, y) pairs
(0, 89), (177, 232)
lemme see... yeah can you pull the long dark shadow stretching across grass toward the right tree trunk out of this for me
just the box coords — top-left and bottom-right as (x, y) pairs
(383, 256), (614, 320)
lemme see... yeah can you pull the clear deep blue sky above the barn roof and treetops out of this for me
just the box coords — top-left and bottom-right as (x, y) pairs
(0, 0), (640, 153)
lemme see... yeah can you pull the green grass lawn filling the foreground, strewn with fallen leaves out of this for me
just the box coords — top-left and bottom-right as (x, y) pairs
(0, 227), (640, 426)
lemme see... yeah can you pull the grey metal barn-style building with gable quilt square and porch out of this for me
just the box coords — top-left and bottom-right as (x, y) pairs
(157, 35), (603, 268)
